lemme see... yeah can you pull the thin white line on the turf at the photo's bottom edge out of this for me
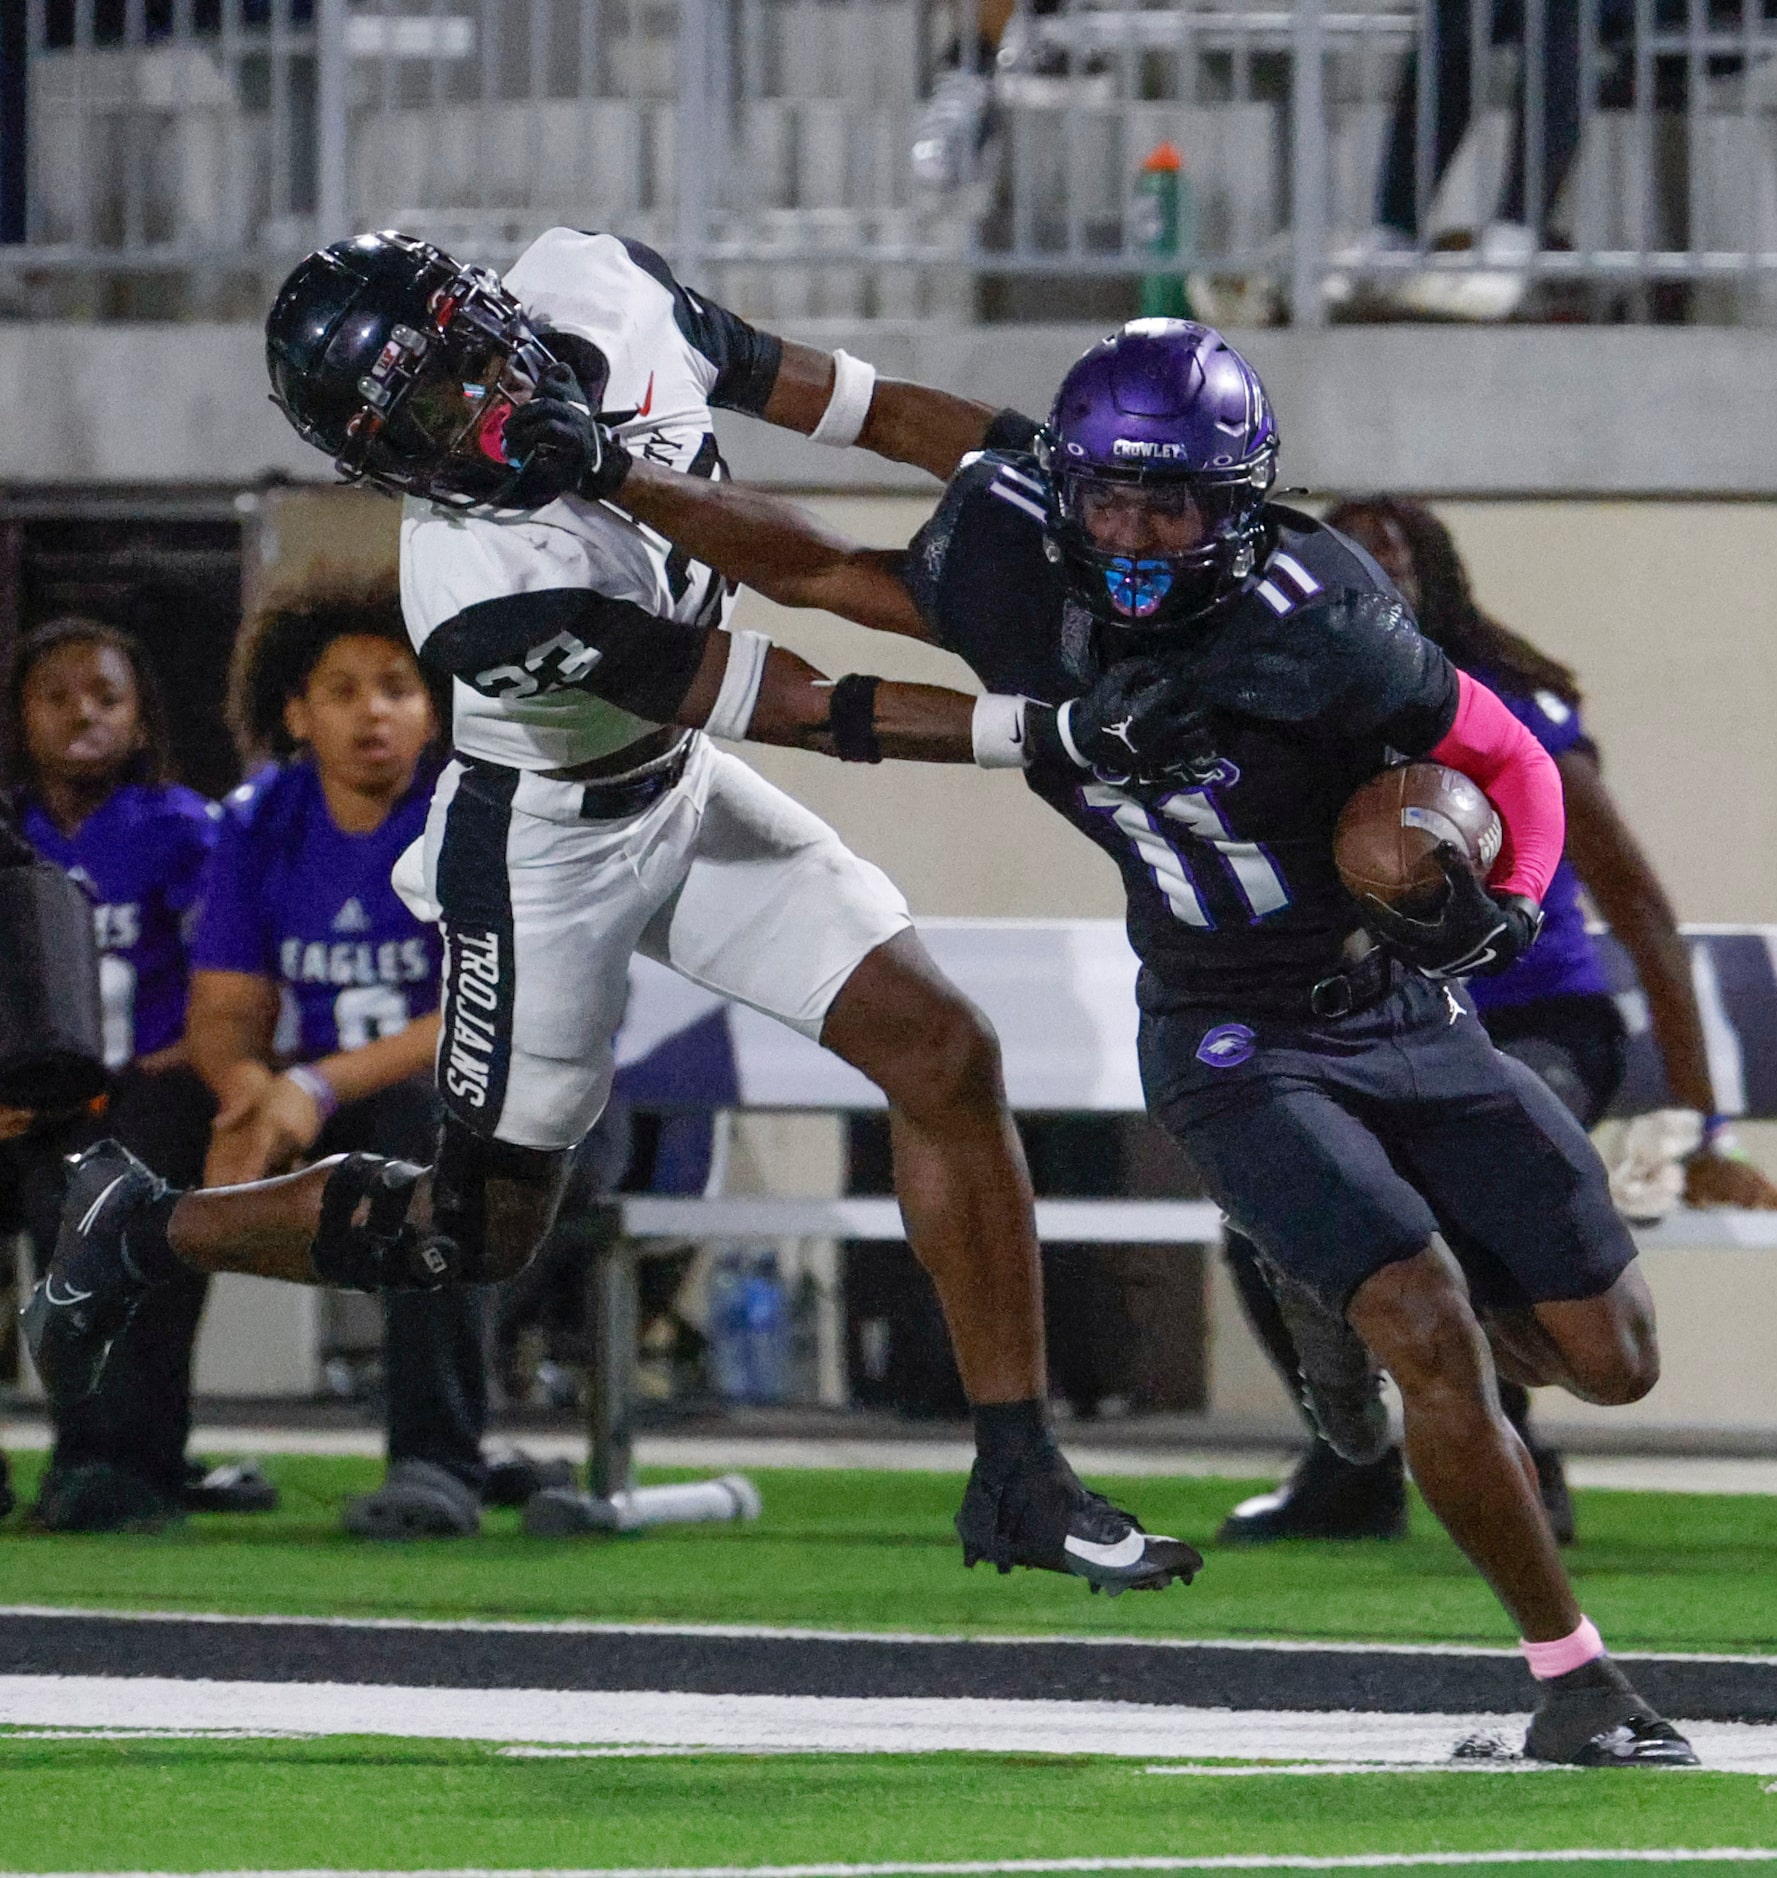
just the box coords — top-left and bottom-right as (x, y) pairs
(10, 1846), (1777, 1878)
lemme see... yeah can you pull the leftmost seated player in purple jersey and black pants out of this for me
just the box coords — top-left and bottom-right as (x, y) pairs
(0, 618), (270, 1531)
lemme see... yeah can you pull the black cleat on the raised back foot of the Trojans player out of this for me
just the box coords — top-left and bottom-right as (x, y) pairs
(21, 1142), (167, 1407)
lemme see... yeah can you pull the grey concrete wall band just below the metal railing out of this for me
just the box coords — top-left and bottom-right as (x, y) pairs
(0, 321), (1777, 496)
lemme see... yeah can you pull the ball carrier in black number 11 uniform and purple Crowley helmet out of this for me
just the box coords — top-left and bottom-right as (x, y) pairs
(484, 319), (1694, 1767)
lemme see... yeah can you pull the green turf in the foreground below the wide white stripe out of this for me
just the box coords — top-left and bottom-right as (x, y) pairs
(0, 1733), (1777, 1872)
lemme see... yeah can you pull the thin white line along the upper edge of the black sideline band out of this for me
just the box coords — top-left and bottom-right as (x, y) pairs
(0, 1604), (1777, 1668)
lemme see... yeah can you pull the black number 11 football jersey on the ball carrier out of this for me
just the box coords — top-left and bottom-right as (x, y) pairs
(904, 453), (1458, 1010)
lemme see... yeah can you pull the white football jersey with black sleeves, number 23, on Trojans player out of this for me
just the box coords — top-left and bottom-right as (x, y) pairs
(400, 229), (781, 770)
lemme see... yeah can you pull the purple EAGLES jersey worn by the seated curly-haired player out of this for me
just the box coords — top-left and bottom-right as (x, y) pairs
(192, 761), (441, 1063)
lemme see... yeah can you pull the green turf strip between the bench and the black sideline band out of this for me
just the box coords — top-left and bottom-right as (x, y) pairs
(0, 1455), (1777, 1652)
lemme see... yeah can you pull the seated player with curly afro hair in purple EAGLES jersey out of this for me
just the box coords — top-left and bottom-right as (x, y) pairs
(190, 582), (487, 1536)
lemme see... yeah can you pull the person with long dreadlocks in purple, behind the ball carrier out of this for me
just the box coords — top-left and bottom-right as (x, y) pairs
(1223, 496), (1777, 1542)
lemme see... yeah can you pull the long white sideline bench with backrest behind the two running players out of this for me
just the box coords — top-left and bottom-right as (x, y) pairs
(574, 920), (1777, 1501)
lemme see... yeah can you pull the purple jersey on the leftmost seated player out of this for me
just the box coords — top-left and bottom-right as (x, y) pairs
(23, 783), (220, 1069)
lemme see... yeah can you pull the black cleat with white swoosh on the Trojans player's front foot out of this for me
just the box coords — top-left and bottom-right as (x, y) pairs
(956, 1448), (1204, 1596)
